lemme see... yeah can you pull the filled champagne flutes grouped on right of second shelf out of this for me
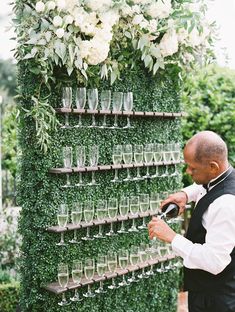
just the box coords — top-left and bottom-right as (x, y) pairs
(112, 143), (181, 182)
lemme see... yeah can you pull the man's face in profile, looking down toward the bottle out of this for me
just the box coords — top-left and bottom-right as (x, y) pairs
(184, 146), (212, 184)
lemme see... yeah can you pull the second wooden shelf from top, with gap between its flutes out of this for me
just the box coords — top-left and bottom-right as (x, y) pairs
(49, 161), (182, 174)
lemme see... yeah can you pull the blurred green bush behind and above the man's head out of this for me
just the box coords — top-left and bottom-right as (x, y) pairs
(182, 65), (235, 184)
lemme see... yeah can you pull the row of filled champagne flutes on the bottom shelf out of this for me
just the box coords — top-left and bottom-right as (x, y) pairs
(58, 243), (181, 305)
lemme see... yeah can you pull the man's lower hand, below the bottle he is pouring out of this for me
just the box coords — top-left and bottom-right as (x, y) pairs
(148, 217), (176, 243)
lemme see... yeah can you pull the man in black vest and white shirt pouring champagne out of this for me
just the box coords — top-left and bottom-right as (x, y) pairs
(149, 131), (235, 312)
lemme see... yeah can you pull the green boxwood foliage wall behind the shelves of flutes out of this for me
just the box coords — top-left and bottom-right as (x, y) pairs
(18, 63), (184, 312)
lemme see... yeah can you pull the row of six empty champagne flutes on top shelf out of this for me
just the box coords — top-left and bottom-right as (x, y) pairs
(62, 87), (133, 129)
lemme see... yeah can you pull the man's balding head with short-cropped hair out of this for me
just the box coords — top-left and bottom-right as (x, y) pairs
(184, 131), (229, 184)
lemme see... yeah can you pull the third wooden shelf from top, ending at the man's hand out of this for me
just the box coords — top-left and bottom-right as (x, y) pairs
(46, 210), (156, 233)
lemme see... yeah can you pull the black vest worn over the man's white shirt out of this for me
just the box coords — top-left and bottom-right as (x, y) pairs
(184, 169), (235, 294)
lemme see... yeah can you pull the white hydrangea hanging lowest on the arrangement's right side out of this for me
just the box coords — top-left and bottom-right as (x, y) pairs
(159, 31), (179, 57)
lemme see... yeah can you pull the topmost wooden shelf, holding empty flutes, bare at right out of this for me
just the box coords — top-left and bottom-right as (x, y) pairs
(55, 108), (187, 118)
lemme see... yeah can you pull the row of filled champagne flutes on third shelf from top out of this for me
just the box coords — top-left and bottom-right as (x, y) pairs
(57, 192), (181, 246)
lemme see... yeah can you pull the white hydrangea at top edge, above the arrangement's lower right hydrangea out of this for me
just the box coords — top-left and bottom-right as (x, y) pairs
(146, 0), (172, 19)
